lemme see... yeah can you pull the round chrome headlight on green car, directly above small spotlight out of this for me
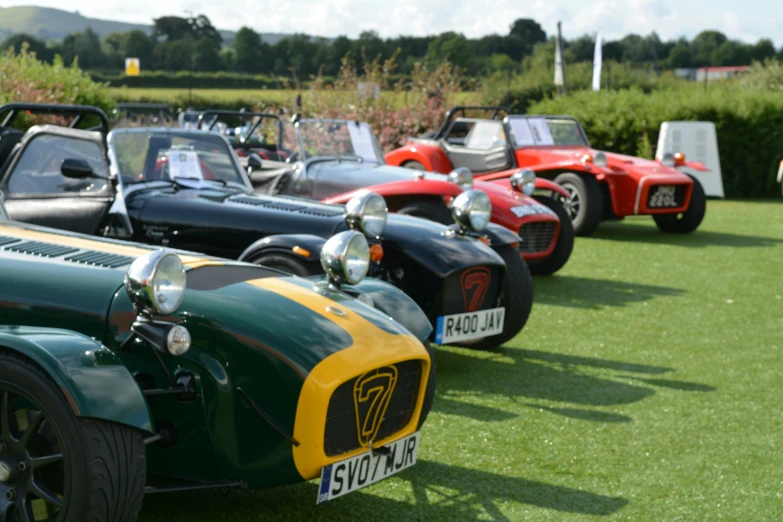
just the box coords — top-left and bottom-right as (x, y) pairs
(125, 249), (187, 315)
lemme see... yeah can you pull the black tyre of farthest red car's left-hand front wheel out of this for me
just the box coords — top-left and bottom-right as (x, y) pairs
(555, 172), (603, 236)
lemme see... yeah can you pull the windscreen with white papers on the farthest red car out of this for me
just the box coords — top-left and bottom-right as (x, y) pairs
(508, 116), (589, 147)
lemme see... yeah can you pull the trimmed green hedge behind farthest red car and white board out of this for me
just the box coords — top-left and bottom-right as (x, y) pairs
(527, 84), (783, 197)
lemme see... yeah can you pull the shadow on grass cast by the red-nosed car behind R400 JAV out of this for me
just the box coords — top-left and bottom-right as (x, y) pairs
(535, 275), (685, 309)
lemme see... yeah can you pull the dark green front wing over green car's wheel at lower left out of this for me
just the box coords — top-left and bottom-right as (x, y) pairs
(0, 326), (155, 433)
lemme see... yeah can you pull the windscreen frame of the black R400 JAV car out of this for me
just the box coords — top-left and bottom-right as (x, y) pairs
(106, 127), (253, 191)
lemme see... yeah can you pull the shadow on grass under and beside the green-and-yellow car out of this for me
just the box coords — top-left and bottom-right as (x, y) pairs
(140, 460), (628, 522)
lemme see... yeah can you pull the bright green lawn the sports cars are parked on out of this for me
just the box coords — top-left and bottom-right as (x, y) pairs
(142, 201), (783, 522)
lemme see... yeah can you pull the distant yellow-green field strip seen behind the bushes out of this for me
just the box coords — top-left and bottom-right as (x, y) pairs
(111, 87), (476, 108)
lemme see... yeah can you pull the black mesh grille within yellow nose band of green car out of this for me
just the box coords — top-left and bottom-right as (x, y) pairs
(324, 360), (422, 457)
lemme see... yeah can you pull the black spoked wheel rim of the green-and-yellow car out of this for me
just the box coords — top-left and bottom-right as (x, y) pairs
(0, 381), (71, 522)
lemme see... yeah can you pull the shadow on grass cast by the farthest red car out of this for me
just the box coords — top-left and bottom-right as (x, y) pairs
(589, 223), (783, 248)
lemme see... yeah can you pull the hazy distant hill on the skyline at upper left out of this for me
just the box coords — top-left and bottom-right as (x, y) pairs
(0, 6), (290, 45)
